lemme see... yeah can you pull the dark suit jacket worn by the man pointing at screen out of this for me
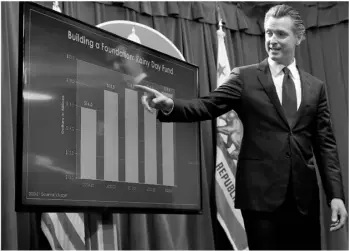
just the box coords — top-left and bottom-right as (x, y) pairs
(158, 60), (344, 213)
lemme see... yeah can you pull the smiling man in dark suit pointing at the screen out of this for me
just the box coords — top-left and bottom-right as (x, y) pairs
(136, 5), (347, 249)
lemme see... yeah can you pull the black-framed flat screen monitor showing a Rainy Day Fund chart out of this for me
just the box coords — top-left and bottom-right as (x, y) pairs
(16, 2), (202, 213)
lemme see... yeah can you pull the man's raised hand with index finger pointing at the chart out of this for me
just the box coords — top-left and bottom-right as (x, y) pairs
(134, 85), (173, 113)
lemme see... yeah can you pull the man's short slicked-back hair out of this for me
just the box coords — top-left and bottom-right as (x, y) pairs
(264, 4), (305, 41)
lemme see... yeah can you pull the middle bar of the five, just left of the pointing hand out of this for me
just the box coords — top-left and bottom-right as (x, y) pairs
(125, 88), (139, 183)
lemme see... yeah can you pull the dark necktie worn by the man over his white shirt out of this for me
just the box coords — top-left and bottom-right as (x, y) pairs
(282, 67), (297, 125)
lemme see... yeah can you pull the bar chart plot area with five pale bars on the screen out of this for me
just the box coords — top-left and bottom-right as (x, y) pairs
(76, 60), (176, 186)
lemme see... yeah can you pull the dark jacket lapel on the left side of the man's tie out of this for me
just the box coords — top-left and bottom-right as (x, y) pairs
(258, 59), (290, 127)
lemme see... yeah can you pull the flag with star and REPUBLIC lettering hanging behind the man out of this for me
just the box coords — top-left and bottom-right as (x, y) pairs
(215, 22), (248, 250)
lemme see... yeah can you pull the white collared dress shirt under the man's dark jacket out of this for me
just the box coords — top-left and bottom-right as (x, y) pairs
(268, 58), (302, 110)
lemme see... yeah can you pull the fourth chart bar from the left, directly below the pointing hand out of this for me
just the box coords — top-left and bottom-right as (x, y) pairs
(143, 109), (157, 184)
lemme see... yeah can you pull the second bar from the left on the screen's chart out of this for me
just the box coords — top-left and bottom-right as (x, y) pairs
(104, 91), (119, 181)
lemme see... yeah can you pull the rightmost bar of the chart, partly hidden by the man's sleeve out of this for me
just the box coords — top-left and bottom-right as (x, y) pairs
(162, 93), (174, 186)
